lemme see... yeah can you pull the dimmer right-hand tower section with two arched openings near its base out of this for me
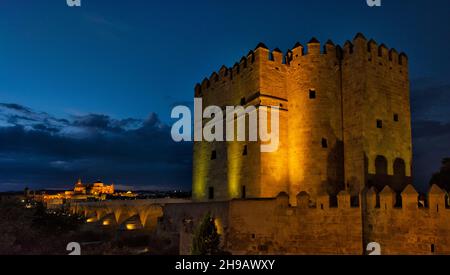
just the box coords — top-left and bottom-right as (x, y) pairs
(342, 35), (412, 193)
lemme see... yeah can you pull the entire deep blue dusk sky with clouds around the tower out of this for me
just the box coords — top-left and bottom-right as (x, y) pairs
(0, 0), (450, 191)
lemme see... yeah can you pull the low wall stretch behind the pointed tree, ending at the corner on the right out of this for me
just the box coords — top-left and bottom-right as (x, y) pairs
(158, 195), (363, 255)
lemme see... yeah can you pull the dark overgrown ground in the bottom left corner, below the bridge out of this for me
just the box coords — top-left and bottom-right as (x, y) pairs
(0, 202), (176, 255)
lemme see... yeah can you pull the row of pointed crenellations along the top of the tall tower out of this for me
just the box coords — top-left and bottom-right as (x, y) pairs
(195, 33), (408, 99)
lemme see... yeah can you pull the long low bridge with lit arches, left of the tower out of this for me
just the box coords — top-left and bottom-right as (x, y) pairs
(69, 199), (189, 230)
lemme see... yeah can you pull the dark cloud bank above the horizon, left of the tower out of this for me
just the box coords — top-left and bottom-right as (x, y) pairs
(0, 103), (192, 191)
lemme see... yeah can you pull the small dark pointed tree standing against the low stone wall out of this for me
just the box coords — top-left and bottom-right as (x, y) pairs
(192, 213), (221, 255)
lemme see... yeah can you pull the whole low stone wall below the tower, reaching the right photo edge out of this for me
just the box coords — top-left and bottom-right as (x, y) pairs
(158, 185), (450, 255)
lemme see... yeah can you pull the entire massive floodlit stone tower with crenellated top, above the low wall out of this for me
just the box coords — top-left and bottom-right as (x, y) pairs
(192, 34), (412, 204)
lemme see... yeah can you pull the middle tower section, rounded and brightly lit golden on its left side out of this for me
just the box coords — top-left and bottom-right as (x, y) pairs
(288, 40), (343, 204)
